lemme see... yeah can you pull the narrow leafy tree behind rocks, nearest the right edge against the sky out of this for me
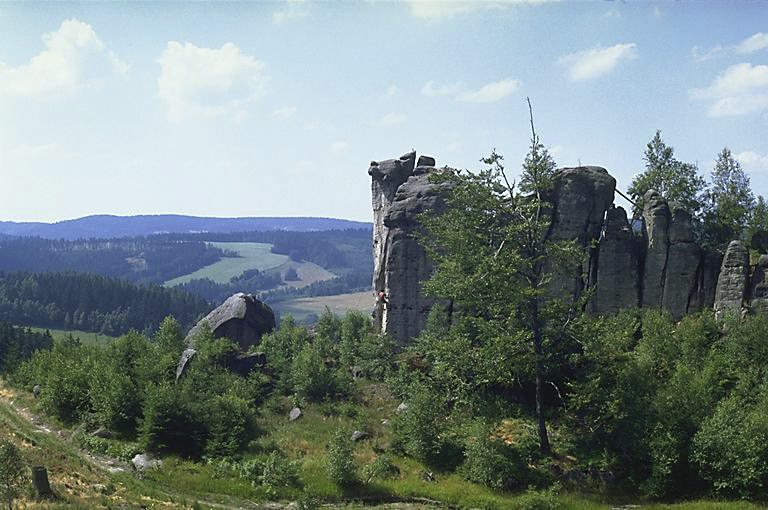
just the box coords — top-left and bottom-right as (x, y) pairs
(702, 147), (755, 252)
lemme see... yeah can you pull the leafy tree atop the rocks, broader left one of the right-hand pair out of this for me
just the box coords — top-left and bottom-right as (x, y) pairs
(627, 130), (705, 217)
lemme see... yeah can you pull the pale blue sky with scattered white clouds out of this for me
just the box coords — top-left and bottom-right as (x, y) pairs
(0, 0), (768, 221)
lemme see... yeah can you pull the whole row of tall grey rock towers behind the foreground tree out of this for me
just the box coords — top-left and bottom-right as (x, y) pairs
(368, 152), (752, 344)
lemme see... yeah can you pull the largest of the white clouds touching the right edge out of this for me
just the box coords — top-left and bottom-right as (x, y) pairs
(690, 62), (768, 117)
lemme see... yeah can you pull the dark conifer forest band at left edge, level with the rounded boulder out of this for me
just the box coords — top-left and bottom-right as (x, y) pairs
(0, 272), (211, 336)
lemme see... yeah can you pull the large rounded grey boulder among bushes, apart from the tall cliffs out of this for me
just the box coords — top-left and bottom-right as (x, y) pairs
(185, 292), (275, 351)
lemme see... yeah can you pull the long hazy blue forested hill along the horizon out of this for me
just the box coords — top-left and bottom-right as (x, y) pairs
(0, 214), (371, 239)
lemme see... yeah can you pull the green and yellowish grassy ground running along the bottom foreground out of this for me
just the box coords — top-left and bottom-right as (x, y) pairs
(0, 381), (765, 510)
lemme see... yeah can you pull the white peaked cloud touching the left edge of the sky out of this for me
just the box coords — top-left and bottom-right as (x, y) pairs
(0, 19), (128, 96)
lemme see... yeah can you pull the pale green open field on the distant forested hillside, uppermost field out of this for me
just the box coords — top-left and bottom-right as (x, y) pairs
(164, 242), (289, 287)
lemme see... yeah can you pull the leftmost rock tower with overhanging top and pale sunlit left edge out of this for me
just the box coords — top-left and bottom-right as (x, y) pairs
(368, 152), (452, 344)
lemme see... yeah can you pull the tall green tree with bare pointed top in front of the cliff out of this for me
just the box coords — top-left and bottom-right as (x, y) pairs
(421, 101), (583, 452)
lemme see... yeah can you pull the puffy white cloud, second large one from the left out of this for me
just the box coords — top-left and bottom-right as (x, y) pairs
(157, 41), (267, 120)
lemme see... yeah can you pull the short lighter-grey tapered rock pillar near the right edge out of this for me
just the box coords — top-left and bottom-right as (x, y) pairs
(715, 241), (749, 318)
